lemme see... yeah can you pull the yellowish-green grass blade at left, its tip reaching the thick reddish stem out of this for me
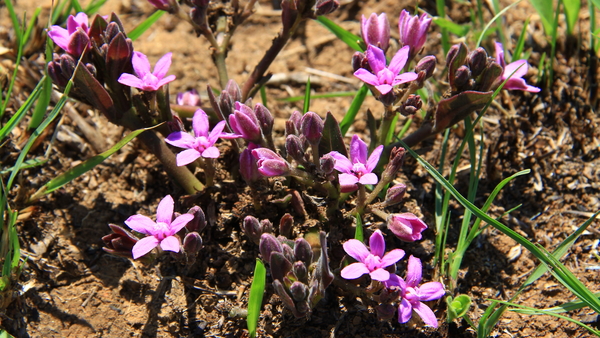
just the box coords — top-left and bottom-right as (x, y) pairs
(30, 125), (158, 201)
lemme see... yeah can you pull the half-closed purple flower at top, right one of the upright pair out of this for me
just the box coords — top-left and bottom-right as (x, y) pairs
(398, 10), (432, 59)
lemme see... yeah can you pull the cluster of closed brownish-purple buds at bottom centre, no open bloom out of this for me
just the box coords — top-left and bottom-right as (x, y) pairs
(259, 231), (334, 318)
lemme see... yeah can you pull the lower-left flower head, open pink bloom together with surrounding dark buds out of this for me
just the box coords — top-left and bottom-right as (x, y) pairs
(102, 195), (206, 264)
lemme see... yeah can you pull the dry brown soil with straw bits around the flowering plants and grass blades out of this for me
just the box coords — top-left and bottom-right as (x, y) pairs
(0, 0), (600, 338)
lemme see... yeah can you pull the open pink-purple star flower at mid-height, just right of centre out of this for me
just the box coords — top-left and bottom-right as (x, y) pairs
(329, 134), (383, 193)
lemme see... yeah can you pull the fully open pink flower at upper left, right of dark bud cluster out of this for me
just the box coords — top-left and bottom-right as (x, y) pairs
(117, 52), (175, 92)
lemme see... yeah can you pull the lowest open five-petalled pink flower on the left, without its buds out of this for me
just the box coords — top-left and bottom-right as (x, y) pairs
(125, 195), (194, 259)
